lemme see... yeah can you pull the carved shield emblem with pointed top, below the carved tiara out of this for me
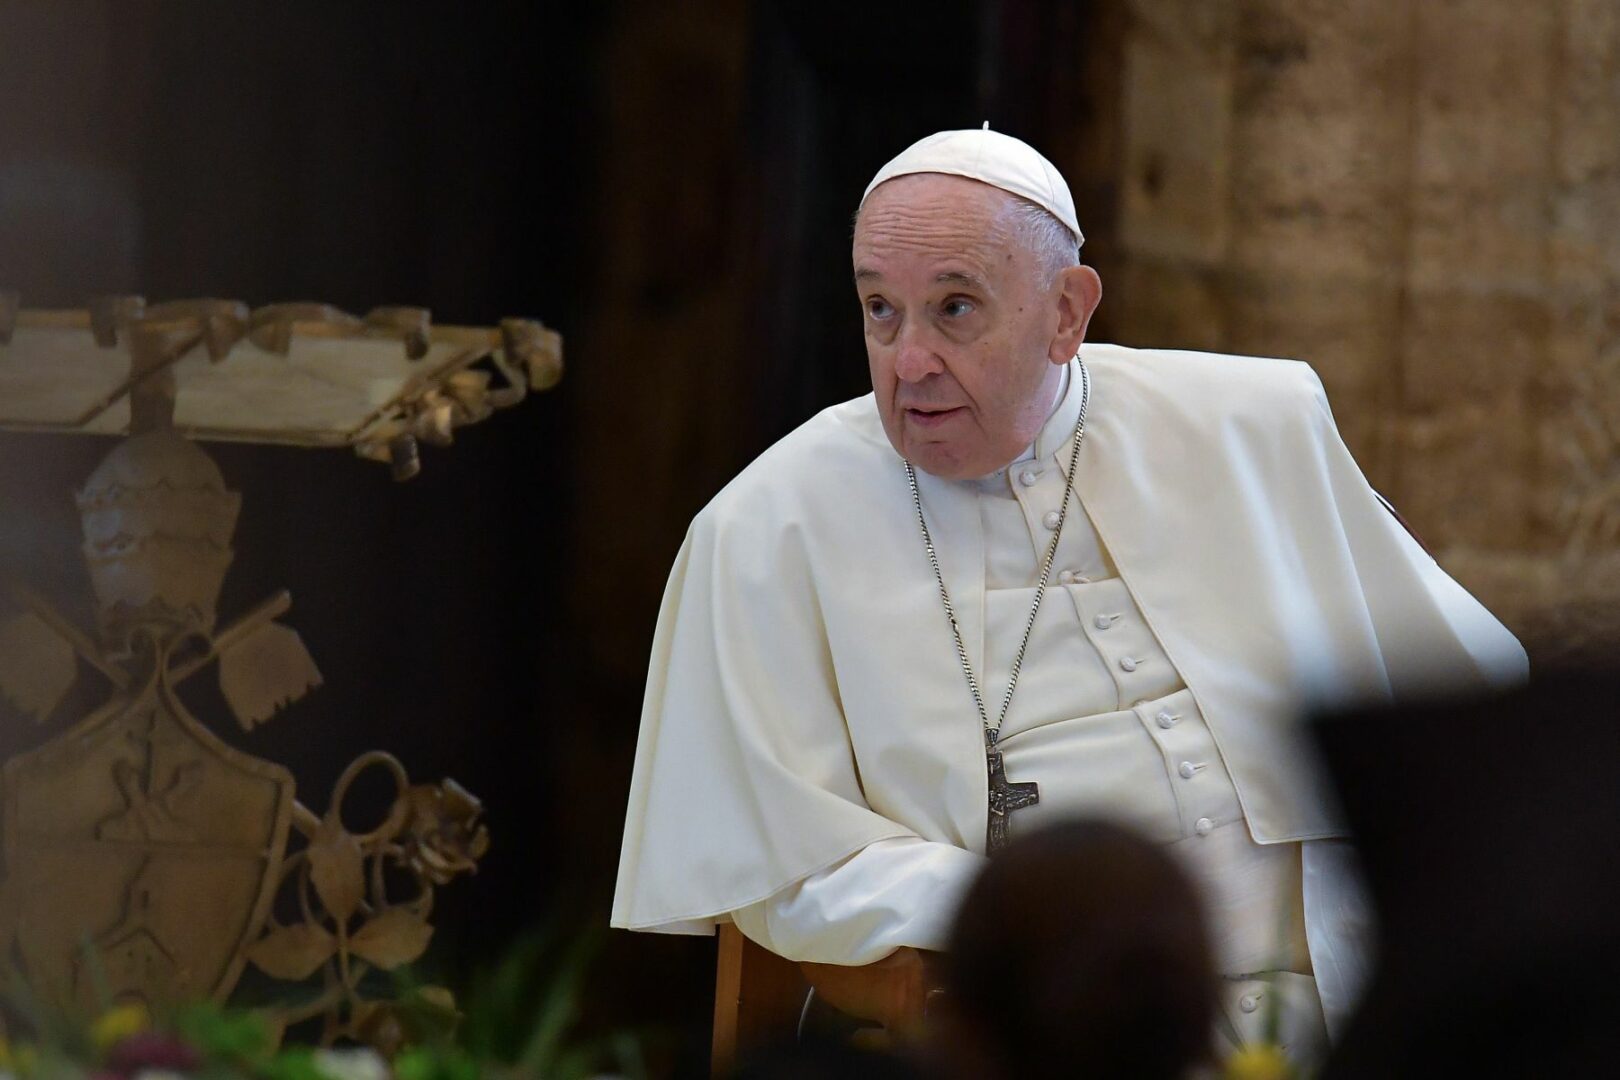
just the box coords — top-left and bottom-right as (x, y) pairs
(0, 680), (293, 1006)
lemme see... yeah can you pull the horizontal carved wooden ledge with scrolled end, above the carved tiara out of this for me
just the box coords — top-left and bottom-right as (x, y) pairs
(0, 291), (562, 473)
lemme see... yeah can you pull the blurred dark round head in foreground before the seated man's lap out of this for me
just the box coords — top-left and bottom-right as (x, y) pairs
(940, 821), (1217, 1078)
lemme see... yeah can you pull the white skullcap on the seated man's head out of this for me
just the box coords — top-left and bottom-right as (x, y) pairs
(860, 123), (1085, 244)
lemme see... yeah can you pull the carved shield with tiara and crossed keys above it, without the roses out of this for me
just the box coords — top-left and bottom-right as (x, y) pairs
(0, 431), (301, 1006)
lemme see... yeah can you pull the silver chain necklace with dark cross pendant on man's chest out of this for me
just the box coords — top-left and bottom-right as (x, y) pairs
(904, 358), (1092, 853)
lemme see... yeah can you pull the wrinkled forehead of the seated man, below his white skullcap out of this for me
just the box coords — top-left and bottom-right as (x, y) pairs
(854, 173), (1016, 262)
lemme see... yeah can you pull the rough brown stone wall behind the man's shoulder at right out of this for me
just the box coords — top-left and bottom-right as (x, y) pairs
(1092, 0), (1620, 661)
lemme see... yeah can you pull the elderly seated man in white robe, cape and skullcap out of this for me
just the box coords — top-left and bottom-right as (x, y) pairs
(612, 125), (1524, 1057)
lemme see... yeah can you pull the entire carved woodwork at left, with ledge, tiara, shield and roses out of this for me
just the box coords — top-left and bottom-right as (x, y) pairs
(0, 299), (531, 1046)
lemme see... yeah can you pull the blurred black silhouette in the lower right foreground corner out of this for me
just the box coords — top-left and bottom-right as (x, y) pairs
(1319, 672), (1620, 1078)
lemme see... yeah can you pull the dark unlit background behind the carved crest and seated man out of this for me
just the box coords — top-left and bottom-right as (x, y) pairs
(0, 0), (1111, 1064)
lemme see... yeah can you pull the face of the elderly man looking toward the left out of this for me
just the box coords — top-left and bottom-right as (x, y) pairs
(854, 173), (1095, 479)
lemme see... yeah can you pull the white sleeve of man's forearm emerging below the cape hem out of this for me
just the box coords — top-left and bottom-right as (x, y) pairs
(731, 837), (985, 965)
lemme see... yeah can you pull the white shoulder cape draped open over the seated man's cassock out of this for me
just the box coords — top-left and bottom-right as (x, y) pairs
(612, 345), (1526, 933)
